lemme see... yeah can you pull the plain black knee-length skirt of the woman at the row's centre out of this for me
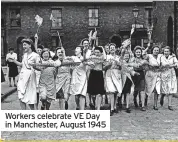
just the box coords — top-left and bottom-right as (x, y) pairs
(87, 70), (105, 95)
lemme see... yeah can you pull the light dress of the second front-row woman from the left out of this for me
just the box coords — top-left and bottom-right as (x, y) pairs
(39, 60), (60, 102)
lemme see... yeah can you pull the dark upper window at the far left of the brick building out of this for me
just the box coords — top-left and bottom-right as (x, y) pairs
(10, 8), (21, 27)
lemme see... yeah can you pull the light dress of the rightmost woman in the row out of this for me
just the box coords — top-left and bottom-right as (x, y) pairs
(161, 55), (178, 95)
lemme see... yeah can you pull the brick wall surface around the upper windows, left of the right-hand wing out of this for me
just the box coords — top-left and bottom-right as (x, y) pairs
(2, 3), (152, 58)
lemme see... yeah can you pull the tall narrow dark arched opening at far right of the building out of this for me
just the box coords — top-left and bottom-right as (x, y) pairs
(167, 16), (173, 50)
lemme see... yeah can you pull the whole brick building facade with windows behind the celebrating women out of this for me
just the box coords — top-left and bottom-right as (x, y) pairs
(1, 1), (175, 64)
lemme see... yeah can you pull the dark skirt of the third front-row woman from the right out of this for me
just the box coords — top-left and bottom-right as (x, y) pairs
(132, 70), (145, 91)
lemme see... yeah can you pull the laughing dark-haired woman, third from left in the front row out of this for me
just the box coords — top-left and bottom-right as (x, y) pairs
(56, 47), (71, 110)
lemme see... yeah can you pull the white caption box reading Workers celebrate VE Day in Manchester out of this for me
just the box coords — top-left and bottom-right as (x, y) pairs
(1, 110), (110, 131)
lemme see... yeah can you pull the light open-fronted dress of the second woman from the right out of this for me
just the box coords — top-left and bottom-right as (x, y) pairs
(145, 54), (162, 96)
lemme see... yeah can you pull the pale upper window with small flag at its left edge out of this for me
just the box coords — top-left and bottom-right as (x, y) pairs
(50, 9), (62, 29)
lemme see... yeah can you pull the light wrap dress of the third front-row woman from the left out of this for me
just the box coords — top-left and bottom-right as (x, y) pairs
(56, 59), (71, 97)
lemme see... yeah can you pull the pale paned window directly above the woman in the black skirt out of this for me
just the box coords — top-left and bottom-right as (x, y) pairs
(89, 8), (99, 27)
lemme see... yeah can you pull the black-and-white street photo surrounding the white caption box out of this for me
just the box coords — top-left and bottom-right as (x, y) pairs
(1, 0), (178, 141)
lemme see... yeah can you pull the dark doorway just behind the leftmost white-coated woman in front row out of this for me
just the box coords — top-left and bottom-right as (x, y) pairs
(17, 37), (24, 62)
